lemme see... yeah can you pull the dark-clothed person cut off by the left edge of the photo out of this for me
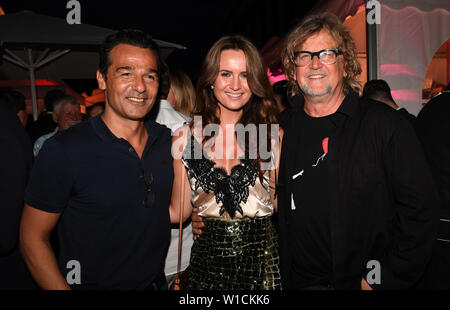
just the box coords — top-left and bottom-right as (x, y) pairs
(0, 95), (36, 290)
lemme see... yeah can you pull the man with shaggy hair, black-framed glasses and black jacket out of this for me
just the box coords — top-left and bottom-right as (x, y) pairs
(279, 13), (437, 289)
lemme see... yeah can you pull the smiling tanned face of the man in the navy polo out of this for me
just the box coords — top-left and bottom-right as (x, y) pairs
(97, 44), (159, 121)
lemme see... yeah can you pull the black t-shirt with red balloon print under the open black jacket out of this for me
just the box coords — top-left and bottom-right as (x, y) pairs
(290, 112), (335, 288)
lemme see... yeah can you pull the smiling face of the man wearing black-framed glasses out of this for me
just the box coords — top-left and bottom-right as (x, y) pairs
(295, 30), (345, 99)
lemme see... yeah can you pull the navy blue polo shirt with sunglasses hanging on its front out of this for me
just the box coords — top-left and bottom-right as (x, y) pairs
(25, 116), (173, 289)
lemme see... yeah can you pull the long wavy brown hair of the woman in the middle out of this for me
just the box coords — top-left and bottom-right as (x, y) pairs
(191, 35), (278, 177)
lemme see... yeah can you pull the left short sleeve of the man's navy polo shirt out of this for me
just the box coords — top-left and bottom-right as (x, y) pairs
(24, 138), (74, 213)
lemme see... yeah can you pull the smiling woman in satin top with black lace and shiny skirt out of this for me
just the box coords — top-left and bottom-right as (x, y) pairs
(170, 36), (281, 290)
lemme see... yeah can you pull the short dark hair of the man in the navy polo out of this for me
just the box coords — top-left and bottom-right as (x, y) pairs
(98, 29), (165, 81)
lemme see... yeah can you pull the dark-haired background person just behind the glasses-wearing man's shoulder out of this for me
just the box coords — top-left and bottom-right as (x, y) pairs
(362, 80), (416, 123)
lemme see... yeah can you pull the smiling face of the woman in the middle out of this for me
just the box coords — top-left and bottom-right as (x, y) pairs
(214, 50), (252, 111)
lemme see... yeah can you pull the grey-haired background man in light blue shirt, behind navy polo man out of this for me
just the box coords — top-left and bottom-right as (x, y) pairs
(33, 95), (81, 157)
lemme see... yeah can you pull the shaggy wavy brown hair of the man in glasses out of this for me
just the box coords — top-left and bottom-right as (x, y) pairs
(281, 13), (361, 95)
